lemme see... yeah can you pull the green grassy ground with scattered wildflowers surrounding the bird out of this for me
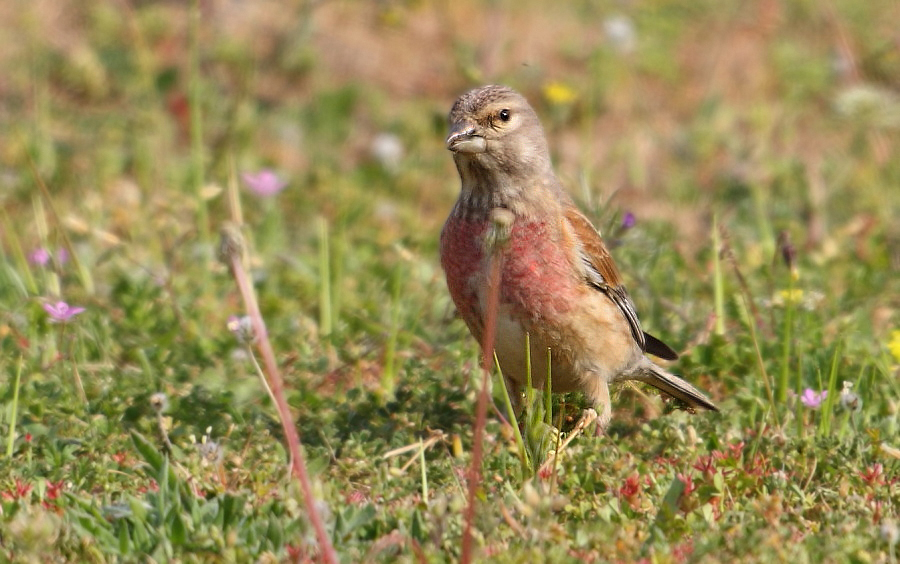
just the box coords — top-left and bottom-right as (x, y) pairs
(0, 0), (900, 562)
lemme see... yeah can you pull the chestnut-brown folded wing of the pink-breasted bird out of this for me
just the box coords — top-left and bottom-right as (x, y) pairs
(565, 207), (648, 354)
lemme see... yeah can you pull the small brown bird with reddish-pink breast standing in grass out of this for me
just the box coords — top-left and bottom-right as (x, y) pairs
(441, 85), (718, 431)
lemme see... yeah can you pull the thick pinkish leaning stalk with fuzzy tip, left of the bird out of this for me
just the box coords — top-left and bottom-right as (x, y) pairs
(221, 225), (338, 564)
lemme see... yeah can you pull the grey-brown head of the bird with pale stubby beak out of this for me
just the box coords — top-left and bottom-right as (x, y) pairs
(447, 85), (555, 203)
